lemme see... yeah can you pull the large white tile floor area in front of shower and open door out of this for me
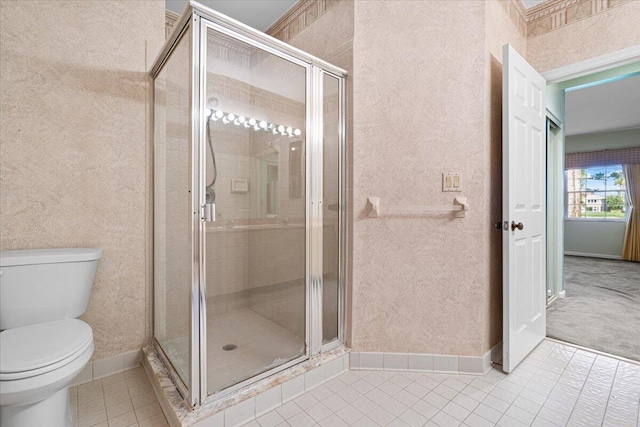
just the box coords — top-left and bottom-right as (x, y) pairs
(245, 340), (640, 427)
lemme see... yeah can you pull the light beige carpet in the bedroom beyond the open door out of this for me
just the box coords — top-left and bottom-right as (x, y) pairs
(547, 256), (640, 361)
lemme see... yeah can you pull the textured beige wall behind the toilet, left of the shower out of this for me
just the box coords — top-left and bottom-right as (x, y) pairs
(0, 0), (164, 360)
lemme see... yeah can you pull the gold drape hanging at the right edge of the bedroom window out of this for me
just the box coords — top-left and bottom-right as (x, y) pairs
(622, 164), (640, 262)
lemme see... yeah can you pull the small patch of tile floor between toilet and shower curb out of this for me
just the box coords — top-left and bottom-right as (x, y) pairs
(69, 367), (168, 427)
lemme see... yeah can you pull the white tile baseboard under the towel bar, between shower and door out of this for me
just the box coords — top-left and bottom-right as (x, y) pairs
(349, 341), (502, 375)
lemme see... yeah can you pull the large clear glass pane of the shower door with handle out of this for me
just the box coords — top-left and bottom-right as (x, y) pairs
(202, 28), (308, 394)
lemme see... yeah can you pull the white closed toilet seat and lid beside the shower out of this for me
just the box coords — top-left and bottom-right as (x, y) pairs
(0, 319), (93, 381)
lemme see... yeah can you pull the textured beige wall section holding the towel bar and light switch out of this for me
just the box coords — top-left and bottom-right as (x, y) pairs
(352, 1), (489, 356)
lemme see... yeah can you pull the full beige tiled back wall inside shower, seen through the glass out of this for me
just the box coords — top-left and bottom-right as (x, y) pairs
(207, 30), (340, 334)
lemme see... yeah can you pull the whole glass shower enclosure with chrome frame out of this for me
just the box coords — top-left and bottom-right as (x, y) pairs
(150, 2), (346, 406)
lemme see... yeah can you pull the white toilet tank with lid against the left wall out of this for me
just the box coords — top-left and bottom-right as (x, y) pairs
(0, 248), (102, 330)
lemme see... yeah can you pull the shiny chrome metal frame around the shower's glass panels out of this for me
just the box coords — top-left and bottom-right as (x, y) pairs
(150, 1), (347, 407)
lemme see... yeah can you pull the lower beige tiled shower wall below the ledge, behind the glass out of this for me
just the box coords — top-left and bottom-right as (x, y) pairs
(207, 225), (338, 340)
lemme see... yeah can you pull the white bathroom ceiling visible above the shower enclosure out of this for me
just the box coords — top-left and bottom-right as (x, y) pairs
(165, 0), (297, 31)
